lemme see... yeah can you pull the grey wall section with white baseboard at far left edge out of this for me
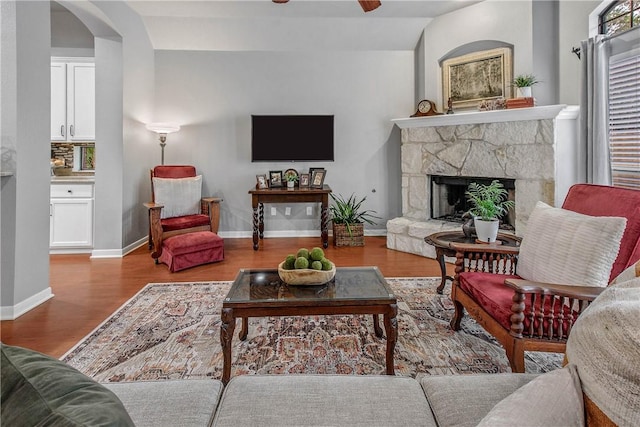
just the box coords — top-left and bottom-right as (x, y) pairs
(0, 1), (51, 318)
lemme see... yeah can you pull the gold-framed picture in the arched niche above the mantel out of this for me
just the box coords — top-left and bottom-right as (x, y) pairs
(442, 47), (513, 109)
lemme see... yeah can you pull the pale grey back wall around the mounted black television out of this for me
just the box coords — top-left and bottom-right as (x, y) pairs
(155, 51), (415, 236)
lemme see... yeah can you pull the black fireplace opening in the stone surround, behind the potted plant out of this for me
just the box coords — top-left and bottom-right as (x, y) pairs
(431, 175), (516, 230)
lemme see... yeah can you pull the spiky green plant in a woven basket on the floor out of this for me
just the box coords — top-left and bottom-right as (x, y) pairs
(329, 193), (380, 246)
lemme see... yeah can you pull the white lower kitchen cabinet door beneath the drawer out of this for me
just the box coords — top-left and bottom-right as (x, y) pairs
(49, 198), (93, 248)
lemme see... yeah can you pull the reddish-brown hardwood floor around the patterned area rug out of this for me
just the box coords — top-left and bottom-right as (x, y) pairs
(1, 237), (453, 357)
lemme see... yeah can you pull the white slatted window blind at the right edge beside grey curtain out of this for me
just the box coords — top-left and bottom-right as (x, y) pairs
(609, 54), (640, 190)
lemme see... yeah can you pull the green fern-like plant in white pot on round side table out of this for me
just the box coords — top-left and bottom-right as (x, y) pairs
(466, 179), (515, 243)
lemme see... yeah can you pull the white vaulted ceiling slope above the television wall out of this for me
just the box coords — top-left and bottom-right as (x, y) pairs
(119, 0), (481, 51)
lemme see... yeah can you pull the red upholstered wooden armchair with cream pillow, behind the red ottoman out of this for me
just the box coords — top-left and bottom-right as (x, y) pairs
(144, 165), (222, 263)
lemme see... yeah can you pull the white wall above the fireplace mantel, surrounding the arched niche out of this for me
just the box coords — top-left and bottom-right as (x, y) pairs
(423, 0), (602, 109)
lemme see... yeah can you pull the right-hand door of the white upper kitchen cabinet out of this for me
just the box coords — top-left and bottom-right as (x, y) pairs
(67, 63), (96, 141)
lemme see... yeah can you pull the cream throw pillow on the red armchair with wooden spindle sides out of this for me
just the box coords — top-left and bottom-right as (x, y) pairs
(517, 202), (627, 287)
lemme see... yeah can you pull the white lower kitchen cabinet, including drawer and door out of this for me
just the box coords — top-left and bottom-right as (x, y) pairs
(49, 183), (94, 249)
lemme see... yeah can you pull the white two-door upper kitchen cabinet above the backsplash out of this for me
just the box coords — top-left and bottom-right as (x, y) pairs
(51, 62), (96, 141)
